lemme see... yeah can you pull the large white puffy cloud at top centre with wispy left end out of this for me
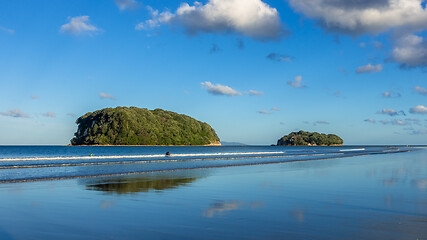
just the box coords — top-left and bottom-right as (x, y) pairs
(135, 0), (286, 40)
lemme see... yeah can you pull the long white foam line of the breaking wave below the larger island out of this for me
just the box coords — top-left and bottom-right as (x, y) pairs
(0, 151), (285, 161)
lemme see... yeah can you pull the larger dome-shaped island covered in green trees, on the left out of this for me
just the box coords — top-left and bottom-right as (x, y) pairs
(71, 107), (221, 146)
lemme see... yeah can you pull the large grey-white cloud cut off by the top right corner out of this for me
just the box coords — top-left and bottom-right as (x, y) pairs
(289, 0), (427, 35)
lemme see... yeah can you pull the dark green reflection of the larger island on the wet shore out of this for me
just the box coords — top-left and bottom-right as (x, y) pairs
(86, 177), (201, 194)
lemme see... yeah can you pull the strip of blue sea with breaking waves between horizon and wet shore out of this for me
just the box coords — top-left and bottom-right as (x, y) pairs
(0, 146), (412, 183)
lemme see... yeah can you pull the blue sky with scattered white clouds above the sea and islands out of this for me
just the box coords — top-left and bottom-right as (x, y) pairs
(0, 0), (427, 145)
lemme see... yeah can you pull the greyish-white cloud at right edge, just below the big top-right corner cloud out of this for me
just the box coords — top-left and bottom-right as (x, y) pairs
(391, 34), (427, 68)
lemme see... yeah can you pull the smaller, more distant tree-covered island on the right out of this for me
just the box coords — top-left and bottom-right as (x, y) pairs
(277, 131), (344, 146)
